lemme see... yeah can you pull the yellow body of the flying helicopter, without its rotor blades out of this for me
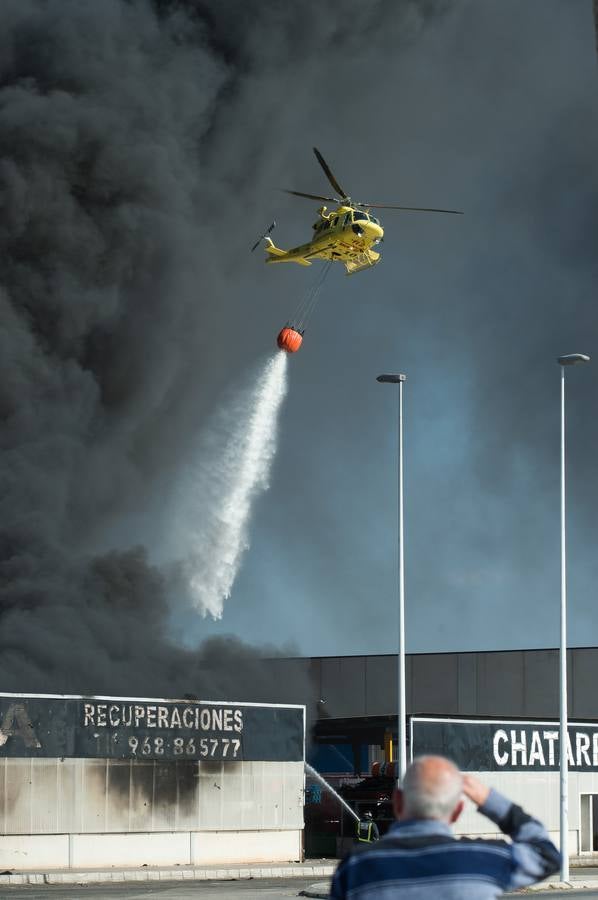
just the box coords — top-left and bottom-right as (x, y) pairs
(266, 205), (384, 275)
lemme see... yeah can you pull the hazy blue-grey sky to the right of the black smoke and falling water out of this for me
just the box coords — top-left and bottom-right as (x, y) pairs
(191, 0), (598, 655)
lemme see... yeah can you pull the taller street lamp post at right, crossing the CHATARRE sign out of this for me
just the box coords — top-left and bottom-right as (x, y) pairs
(557, 353), (590, 881)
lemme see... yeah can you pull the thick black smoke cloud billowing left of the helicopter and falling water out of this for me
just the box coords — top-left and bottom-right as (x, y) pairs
(0, 0), (446, 700)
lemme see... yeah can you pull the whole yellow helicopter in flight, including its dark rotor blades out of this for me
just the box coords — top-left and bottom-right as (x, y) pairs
(251, 147), (463, 275)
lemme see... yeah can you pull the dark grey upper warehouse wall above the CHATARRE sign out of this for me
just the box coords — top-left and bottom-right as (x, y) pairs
(278, 647), (598, 719)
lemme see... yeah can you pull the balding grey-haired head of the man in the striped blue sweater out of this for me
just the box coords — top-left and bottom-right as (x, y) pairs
(396, 756), (463, 822)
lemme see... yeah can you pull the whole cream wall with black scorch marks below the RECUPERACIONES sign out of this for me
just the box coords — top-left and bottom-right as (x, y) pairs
(0, 758), (304, 869)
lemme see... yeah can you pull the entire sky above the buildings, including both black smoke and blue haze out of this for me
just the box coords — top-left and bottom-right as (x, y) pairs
(0, 0), (598, 699)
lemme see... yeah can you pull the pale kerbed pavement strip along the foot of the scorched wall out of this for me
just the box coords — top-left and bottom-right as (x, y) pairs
(0, 859), (340, 884)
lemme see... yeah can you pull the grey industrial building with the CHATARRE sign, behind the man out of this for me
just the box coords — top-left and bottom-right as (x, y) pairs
(276, 647), (598, 863)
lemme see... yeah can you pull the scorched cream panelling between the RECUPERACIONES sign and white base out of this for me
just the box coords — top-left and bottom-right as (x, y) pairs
(0, 758), (304, 834)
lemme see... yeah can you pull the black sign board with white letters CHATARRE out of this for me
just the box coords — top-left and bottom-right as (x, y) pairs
(411, 716), (598, 772)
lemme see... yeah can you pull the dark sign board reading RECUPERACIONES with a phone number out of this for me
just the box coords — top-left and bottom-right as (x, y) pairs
(0, 694), (305, 762)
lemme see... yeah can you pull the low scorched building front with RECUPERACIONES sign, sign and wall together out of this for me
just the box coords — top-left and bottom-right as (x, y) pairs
(0, 694), (305, 869)
